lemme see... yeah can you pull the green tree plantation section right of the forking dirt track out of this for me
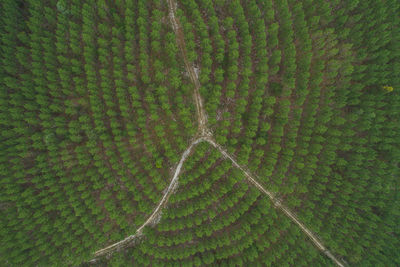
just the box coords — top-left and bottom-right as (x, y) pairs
(172, 0), (399, 266)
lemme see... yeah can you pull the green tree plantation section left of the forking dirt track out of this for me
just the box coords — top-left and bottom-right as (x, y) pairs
(0, 0), (195, 266)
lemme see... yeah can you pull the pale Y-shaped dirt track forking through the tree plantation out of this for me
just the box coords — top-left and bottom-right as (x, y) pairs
(91, 0), (345, 267)
